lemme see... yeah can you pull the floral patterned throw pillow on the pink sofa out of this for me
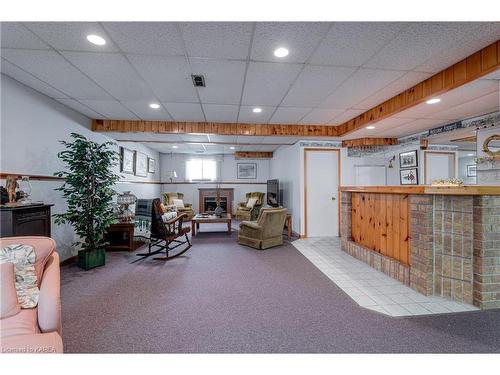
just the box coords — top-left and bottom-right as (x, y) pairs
(0, 244), (40, 309)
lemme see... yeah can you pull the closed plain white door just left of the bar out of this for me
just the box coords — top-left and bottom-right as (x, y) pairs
(305, 150), (339, 237)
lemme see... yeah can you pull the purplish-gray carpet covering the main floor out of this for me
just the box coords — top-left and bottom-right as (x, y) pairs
(61, 232), (500, 353)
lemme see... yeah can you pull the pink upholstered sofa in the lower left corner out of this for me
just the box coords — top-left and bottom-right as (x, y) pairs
(0, 237), (63, 353)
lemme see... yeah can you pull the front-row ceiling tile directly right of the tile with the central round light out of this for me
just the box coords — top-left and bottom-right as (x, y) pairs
(309, 22), (404, 66)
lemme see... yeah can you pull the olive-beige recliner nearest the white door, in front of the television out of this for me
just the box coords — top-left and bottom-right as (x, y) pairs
(238, 208), (288, 250)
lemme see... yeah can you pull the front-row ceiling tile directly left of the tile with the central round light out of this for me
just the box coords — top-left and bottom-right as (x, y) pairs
(179, 22), (253, 60)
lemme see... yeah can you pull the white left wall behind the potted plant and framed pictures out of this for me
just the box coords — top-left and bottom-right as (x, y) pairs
(0, 74), (160, 260)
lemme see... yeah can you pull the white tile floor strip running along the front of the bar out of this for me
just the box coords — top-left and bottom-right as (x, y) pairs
(292, 237), (479, 317)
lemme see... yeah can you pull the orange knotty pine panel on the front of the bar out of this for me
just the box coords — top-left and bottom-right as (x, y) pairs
(351, 193), (410, 265)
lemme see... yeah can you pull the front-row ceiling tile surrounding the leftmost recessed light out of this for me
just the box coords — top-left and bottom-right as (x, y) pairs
(24, 22), (118, 52)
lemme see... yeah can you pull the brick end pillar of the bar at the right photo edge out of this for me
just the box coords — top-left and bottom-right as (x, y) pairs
(473, 196), (500, 309)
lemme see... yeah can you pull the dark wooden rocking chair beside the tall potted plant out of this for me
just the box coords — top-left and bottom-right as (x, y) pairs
(137, 198), (191, 261)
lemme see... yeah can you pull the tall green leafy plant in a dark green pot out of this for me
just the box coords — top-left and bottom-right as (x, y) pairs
(54, 133), (119, 270)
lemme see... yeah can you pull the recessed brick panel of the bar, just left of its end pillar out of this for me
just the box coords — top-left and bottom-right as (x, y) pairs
(434, 195), (473, 304)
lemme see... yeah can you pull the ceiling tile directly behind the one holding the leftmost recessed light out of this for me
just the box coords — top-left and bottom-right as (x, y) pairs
(62, 52), (153, 100)
